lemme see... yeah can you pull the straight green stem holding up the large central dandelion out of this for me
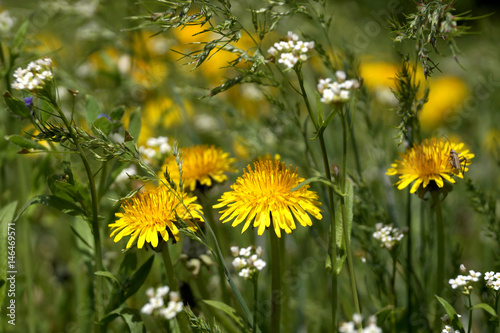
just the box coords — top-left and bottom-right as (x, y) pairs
(270, 227), (282, 333)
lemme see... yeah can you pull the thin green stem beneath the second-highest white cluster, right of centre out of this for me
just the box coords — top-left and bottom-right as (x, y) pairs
(339, 112), (361, 313)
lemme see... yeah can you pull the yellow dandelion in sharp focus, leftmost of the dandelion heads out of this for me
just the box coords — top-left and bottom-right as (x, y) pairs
(108, 185), (202, 249)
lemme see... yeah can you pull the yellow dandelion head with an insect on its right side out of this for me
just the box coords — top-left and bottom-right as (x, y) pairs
(386, 138), (474, 193)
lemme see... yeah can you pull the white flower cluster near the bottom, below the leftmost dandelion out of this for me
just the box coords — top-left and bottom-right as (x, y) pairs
(141, 286), (183, 320)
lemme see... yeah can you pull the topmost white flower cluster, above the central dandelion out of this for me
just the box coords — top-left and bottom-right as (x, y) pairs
(267, 31), (314, 69)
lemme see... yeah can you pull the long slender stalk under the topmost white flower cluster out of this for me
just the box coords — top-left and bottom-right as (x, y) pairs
(295, 69), (338, 332)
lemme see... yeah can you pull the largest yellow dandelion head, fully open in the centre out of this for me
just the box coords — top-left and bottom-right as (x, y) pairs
(214, 160), (322, 237)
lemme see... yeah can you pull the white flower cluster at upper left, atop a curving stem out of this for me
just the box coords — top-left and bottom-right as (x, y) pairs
(12, 58), (53, 91)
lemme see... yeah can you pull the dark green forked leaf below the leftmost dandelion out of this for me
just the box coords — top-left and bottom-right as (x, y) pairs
(106, 253), (154, 312)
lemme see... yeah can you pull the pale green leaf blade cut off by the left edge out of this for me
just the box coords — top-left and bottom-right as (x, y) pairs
(0, 201), (17, 305)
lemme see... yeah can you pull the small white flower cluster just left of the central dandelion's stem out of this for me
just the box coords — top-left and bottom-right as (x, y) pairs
(231, 246), (266, 280)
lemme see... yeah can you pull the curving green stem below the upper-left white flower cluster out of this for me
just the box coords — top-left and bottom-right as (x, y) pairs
(50, 96), (104, 332)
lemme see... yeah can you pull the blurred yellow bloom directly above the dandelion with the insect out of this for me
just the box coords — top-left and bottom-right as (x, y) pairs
(419, 76), (468, 130)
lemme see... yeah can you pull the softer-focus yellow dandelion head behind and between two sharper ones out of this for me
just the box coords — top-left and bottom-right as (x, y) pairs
(160, 145), (236, 191)
